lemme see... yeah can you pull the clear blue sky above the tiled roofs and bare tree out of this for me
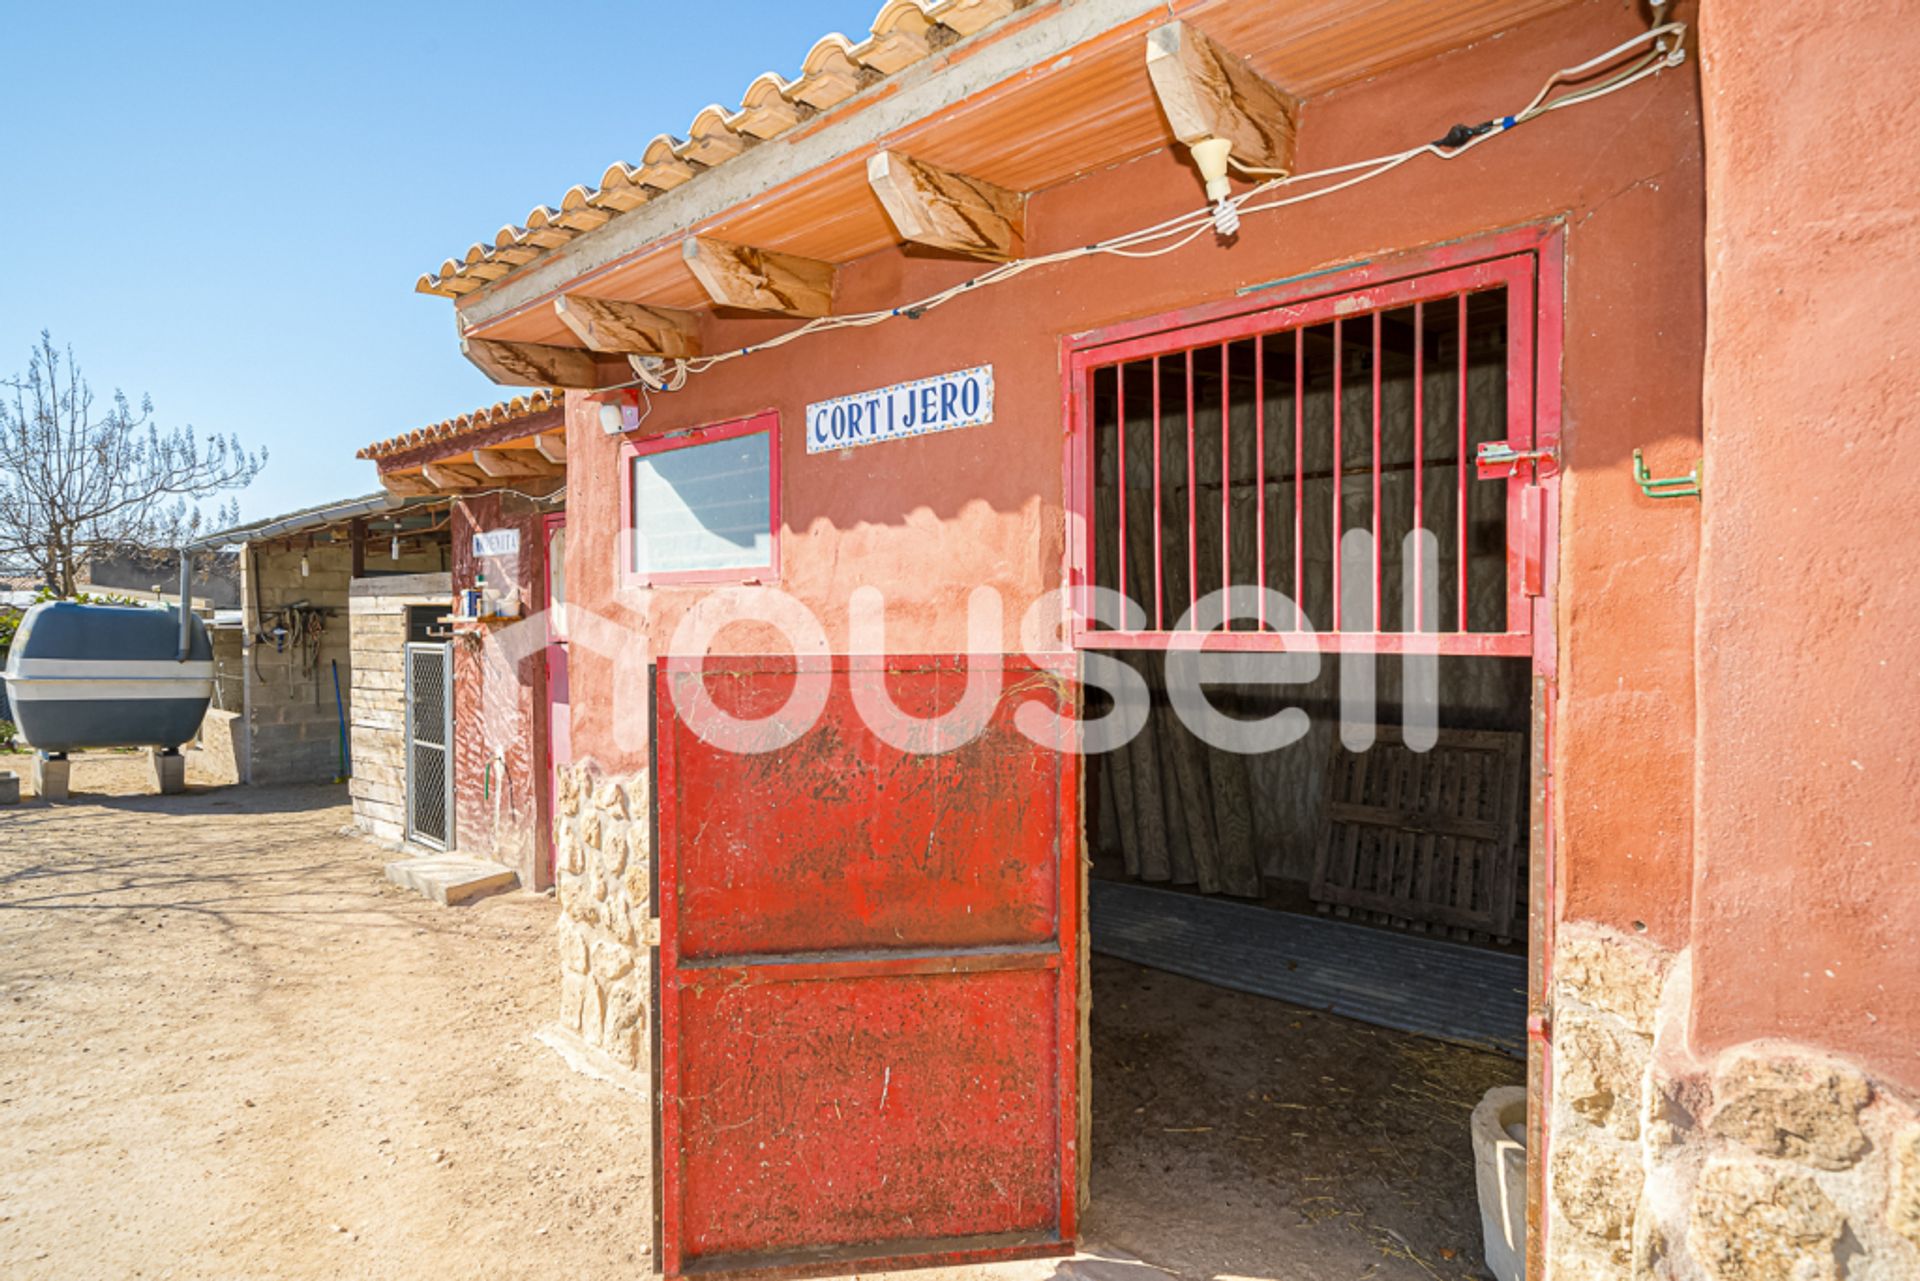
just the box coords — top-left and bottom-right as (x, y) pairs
(0, 0), (879, 519)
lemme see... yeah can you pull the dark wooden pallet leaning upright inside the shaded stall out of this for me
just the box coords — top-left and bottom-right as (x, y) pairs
(1309, 726), (1526, 943)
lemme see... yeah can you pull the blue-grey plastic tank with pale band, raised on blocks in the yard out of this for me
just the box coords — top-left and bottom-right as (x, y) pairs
(6, 601), (213, 753)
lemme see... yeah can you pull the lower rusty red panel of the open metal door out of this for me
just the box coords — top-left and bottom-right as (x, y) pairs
(680, 970), (1060, 1256)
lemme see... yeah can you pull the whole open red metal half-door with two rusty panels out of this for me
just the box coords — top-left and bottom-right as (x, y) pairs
(657, 657), (1079, 1275)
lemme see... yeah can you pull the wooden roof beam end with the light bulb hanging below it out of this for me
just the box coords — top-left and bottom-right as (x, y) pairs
(1146, 23), (1300, 173)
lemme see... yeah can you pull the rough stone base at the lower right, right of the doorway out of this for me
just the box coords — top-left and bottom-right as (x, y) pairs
(1548, 926), (1920, 1281)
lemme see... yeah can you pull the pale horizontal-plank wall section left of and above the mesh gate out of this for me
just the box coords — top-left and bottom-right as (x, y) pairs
(348, 574), (453, 845)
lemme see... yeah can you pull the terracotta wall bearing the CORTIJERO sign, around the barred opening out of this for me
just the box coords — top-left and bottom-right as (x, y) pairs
(568, 0), (1703, 945)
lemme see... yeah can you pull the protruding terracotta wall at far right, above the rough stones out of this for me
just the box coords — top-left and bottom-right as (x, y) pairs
(1697, 0), (1920, 1089)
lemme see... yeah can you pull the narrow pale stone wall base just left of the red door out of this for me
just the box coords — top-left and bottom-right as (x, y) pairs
(555, 762), (653, 1074)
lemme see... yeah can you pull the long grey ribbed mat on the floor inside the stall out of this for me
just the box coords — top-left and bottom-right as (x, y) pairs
(1089, 882), (1526, 1058)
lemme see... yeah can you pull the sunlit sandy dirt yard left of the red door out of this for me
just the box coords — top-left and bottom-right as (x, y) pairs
(0, 755), (651, 1279)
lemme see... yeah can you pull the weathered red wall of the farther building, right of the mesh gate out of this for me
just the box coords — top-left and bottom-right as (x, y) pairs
(453, 494), (553, 889)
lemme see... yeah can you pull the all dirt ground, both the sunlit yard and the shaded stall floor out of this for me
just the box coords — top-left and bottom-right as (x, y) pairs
(0, 755), (1521, 1281)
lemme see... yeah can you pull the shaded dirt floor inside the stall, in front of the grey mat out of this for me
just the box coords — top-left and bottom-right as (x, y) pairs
(1085, 956), (1524, 1281)
